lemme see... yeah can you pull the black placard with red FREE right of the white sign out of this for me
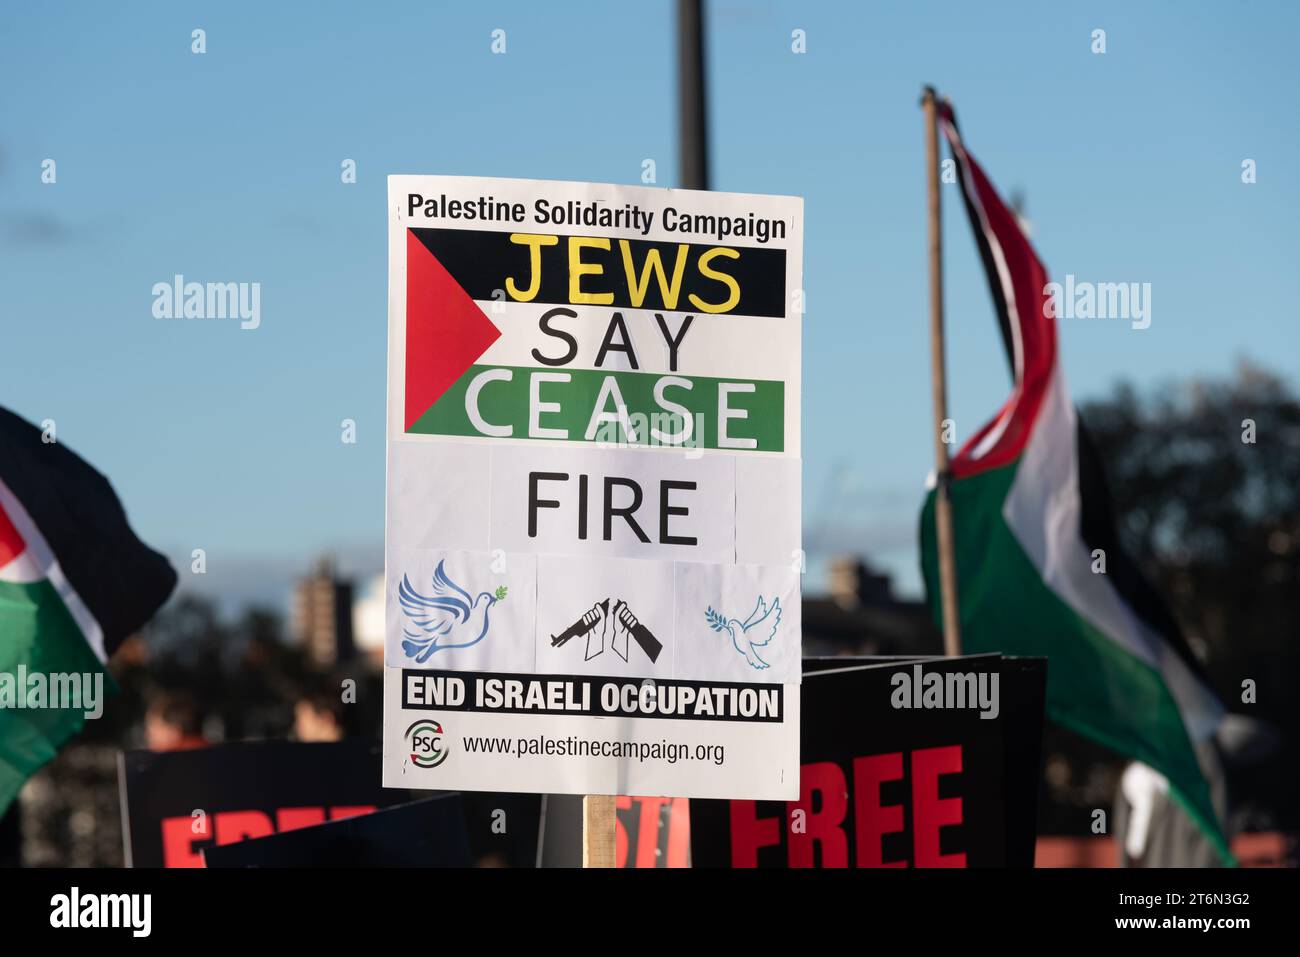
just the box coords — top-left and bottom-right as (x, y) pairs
(690, 655), (1047, 867)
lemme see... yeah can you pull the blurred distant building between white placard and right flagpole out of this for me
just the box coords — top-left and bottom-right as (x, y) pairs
(803, 557), (944, 657)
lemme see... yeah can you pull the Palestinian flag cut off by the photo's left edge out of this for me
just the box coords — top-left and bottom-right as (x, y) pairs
(0, 408), (176, 814)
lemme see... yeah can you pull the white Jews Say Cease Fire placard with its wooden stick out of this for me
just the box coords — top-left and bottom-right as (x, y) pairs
(384, 176), (803, 863)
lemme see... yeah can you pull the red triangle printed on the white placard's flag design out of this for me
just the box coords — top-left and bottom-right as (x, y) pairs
(404, 229), (501, 432)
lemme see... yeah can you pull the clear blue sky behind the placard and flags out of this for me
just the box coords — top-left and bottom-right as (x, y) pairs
(0, 0), (1300, 608)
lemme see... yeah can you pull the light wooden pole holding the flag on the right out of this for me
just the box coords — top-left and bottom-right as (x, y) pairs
(920, 86), (962, 655)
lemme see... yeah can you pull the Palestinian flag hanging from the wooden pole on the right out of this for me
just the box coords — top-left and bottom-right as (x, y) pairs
(920, 104), (1231, 861)
